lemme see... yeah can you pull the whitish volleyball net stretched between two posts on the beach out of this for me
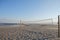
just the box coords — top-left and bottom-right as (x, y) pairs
(20, 19), (54, 24)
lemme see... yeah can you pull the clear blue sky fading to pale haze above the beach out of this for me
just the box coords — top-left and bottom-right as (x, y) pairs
(0, 0), (60, 22)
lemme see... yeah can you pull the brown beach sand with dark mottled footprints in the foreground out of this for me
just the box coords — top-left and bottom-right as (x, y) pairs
(0, 24), (59, 40)
